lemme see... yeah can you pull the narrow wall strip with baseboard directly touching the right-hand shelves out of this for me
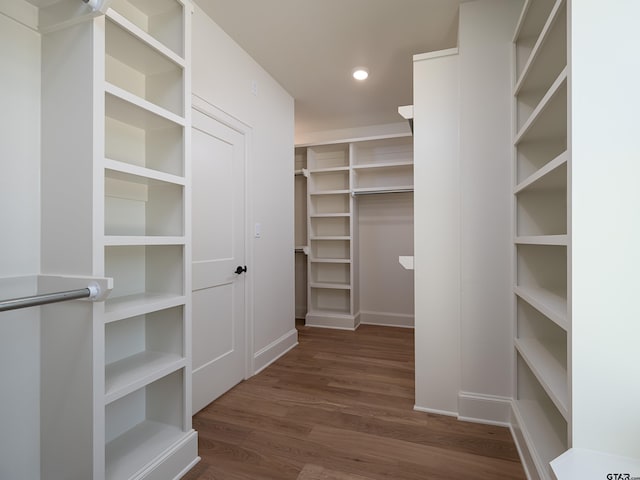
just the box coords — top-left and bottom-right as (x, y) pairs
(458, 0), (522, 422)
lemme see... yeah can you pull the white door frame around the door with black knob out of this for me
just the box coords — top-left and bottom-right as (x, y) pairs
(189, 93), (255, 380)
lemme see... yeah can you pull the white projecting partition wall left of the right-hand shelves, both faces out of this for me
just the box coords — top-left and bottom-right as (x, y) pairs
(414, 0), (521, 423)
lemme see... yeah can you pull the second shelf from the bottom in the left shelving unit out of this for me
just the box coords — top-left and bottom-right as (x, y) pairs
(105, 351), (186, 405)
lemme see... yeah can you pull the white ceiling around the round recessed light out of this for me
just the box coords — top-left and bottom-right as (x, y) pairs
(195, 0), (465, 135)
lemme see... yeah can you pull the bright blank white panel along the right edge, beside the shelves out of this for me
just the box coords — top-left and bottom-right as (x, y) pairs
(569, 0), (640, 460)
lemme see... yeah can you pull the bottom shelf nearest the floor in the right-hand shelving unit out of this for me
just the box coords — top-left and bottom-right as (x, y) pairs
(513, 400), (567, 476)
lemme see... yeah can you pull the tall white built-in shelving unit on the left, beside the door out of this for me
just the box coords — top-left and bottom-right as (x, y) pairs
(42, 0), (198, 480)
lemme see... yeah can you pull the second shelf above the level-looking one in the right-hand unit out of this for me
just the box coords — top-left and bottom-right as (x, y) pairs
(514, 67), (567, 145)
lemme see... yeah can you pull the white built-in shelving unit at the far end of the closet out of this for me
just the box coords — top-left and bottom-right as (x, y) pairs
(296, 137), (413, 329)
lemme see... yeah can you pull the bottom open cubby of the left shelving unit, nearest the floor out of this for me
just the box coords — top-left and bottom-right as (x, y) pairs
(105, 368), (186, 480)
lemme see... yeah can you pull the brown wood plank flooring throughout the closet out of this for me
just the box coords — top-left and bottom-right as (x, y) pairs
(184, 325), (526, 480)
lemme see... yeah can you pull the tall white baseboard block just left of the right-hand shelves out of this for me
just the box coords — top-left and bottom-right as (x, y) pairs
(458, 392), (511, 427)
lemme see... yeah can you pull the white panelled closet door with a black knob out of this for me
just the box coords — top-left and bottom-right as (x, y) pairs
(192, 110), (246, 413)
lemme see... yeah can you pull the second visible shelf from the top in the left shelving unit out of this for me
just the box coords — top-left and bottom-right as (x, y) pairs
(105, 82), (186, 129)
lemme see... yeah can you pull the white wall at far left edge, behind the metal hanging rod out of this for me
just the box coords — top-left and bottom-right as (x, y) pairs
(0, 3), (40, 480)
